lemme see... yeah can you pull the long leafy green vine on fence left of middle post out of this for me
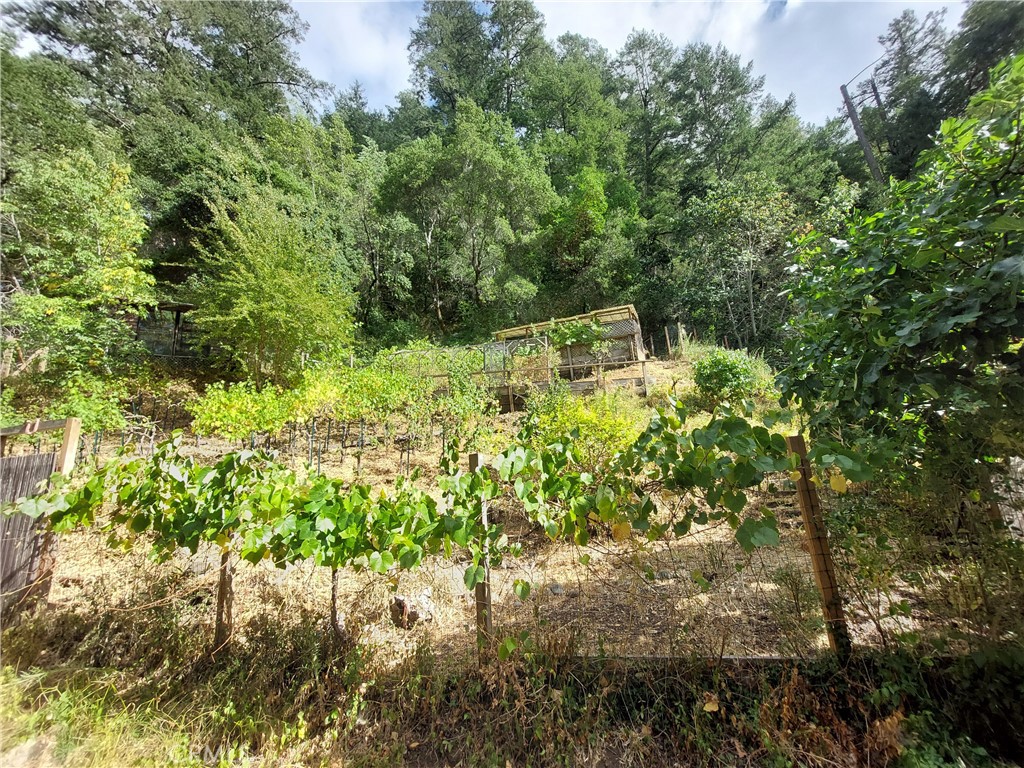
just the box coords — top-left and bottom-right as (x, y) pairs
(8, 434), (491, 583)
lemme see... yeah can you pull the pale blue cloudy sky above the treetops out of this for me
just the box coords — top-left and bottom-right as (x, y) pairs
(293, 0), (963, 124)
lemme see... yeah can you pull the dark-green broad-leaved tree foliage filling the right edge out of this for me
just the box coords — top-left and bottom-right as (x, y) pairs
(779, 57), (1024, 501)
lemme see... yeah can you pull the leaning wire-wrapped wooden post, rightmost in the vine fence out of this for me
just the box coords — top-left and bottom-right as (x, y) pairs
(785, 434), (852, 660)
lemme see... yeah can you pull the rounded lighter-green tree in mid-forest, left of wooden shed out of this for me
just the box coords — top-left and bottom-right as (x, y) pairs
(384, 101), (555, 329)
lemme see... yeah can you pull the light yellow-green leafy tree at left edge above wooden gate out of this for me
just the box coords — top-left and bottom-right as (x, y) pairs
(3, 144), (154, 429)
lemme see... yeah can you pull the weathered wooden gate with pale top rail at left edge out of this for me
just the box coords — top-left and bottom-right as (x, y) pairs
(0, 419), (81, 626)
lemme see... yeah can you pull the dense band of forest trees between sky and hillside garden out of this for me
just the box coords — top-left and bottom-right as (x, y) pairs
(0, 0), (1024, 397)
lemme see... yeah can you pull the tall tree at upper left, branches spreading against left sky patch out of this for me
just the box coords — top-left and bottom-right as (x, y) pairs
(9, 0), (323, 281)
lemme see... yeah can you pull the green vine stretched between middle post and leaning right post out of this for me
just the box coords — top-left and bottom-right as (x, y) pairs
(493, 403), (806, 551)
